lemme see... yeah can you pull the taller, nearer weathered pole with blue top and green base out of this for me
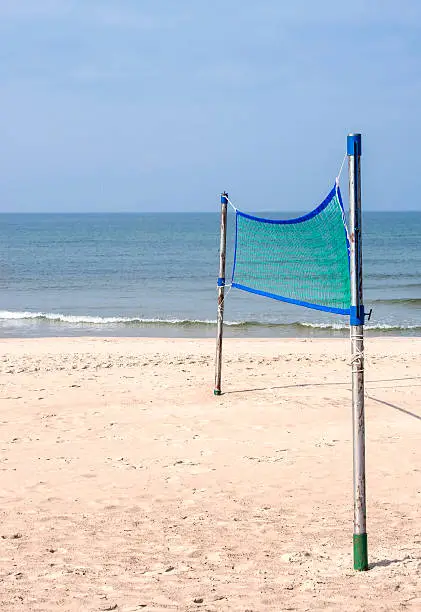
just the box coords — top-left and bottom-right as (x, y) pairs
(347, 134), (368, 571)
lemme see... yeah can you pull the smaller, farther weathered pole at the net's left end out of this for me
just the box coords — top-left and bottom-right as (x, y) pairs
(214, 192), (228, 395)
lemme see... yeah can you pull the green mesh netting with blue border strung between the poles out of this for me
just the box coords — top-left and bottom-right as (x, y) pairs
(232, 186), (350, 314)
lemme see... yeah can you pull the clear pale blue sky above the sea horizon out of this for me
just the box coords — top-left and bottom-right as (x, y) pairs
(0, 0), (421, 212)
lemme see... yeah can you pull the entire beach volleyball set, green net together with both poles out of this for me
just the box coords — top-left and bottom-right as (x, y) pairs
(214, 134), (371, 571)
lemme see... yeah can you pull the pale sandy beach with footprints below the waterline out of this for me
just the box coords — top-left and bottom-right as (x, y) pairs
(0, 337), (421, 612)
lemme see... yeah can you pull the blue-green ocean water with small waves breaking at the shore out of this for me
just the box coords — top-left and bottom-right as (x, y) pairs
(0, 212), (421, 337)
